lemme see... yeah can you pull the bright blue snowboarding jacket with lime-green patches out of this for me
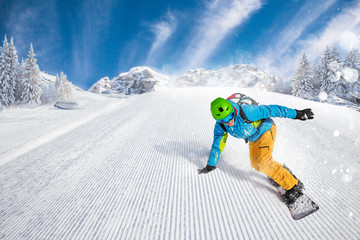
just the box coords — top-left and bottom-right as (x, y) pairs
(207, 101), (296, 166)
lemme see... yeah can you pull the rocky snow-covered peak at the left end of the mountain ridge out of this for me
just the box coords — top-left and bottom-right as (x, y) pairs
(89, 67), (169, 95)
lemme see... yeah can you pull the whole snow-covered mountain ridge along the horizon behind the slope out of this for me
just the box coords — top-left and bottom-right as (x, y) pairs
(89, 64), (290, 94)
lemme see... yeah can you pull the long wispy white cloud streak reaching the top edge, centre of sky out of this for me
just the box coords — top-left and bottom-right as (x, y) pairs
(182, 0), (261, 69)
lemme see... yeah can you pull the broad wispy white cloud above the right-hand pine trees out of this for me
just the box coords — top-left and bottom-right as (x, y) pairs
(254, 0), (360, 76)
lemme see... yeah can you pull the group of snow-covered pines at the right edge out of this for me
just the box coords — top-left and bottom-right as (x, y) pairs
(291, 45), (360, 104)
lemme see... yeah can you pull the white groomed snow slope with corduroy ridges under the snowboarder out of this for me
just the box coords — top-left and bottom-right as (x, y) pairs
(0, 88), (360, 239)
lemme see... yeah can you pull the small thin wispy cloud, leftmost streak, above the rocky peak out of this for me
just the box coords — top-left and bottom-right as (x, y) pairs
(146, 11), (177, 65)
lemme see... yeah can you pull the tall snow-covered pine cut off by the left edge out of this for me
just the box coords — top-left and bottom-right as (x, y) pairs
(0, 36), (19, 107)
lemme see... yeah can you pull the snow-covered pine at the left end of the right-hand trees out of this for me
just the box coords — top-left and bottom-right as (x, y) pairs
(291, 53), (315, 100)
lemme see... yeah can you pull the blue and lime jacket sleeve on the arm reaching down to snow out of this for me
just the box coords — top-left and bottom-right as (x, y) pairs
(207, 123), (228, 166)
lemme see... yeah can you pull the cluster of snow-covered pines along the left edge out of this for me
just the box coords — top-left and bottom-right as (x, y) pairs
(0, 36), (73, 110)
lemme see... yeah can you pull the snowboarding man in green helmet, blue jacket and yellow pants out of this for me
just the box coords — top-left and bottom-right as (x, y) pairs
(199, 98), (314, 203)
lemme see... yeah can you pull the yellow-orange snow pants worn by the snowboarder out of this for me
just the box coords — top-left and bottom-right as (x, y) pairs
(249, 124), (298, 190)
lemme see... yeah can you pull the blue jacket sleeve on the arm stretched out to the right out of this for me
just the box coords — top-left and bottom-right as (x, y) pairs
(241, 105), (296, 121)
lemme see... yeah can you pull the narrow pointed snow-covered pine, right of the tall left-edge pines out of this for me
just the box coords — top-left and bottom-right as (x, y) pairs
(20, 44), (41, 105)
